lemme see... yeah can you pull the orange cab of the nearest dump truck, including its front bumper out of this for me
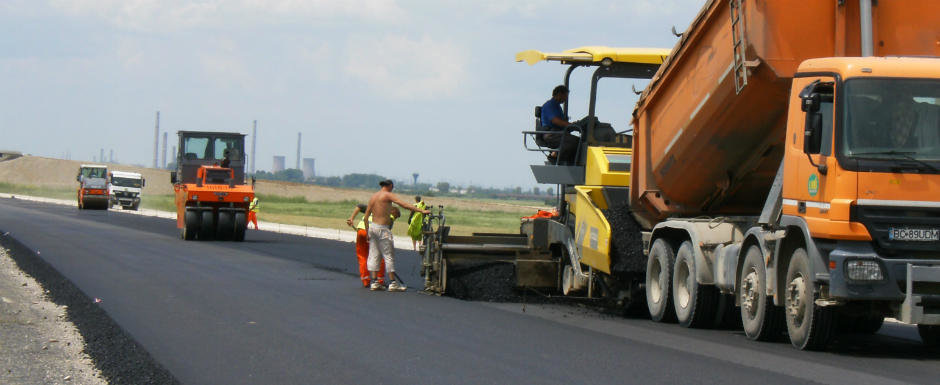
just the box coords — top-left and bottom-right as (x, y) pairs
(778, 57), (940, 325)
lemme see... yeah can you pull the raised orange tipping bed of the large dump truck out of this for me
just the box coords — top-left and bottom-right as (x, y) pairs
(631, 0), (940, 226)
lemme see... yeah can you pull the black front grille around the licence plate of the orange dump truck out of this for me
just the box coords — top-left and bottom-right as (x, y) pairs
(851, 206), (940, 258)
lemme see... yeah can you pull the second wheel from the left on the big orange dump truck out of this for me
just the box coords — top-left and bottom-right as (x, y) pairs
(672, 241), (718, 328)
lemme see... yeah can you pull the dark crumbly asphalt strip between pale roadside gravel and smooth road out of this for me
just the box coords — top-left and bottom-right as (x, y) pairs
(0, 230), (179, 384)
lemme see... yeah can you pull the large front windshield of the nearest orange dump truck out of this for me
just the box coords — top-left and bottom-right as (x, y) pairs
(842, 79), (940, 162)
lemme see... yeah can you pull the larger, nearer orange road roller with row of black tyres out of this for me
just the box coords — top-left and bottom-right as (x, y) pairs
(170, 131), (255, 241)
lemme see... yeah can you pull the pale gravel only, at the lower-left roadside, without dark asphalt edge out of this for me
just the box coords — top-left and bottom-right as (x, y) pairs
(0, 244), (107, 384)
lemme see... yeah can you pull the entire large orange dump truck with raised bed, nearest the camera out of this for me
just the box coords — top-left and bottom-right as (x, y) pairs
(629, 0), (940, 349)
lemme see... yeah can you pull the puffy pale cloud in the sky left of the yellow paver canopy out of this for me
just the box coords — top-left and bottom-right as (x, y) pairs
(346, 35), (466, 100)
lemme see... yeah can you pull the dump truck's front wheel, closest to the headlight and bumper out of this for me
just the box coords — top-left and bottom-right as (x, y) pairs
(783, 248), (833, 350)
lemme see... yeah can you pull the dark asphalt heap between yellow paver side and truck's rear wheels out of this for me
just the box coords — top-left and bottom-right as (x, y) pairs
(603, 205), (646, 273)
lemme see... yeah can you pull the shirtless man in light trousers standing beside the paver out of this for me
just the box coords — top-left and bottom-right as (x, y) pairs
(364, 179), (431, 291)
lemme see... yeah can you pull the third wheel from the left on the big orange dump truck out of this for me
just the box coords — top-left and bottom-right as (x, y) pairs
(738, 246), (783, 341)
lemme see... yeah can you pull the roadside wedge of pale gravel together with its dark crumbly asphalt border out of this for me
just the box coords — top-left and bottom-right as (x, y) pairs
(0, 229), (179, 384)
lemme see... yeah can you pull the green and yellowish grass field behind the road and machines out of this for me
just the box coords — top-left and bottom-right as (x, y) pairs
(0, 182), (534, 235)
